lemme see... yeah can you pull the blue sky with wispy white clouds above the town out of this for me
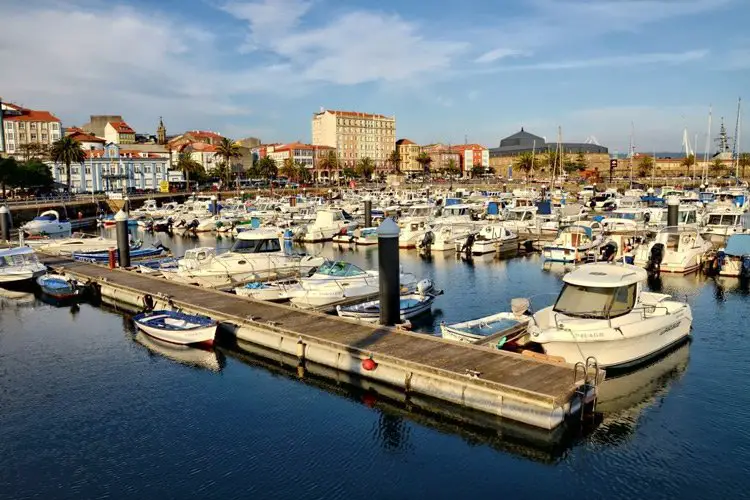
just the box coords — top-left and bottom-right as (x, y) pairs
(0, 0), (750, 151)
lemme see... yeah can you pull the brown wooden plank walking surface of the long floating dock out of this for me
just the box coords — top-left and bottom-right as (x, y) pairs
(40, 255), (592, 406)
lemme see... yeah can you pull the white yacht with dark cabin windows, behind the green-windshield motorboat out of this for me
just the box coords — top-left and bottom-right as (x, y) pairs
(162, 229), (325, 287)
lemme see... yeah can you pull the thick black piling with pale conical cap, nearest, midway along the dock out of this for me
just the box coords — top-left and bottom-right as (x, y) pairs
(378, 217), (401, 326)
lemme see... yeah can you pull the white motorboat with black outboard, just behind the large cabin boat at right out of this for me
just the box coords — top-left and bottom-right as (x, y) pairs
(634, 226), (713, 274)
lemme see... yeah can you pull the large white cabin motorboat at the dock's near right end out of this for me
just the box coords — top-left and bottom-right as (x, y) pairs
(528, 264), (693, 368)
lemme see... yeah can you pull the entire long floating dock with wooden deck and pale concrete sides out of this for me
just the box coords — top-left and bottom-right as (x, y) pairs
(39, 254), (603, 430)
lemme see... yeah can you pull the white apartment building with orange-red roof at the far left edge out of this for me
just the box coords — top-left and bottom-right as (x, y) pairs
(0, 102), (63, 155)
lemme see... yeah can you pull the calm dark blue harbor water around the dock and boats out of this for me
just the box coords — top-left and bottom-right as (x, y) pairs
(0, 228), (750, 499)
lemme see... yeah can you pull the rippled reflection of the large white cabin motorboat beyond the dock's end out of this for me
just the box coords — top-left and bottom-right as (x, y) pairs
(590, 341), (690, 445)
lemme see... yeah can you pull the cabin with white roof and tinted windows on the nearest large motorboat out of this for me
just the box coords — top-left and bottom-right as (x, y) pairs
(552, 264), (648, 318)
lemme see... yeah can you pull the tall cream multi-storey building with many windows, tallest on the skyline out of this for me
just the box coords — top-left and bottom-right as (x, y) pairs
(312, 110), (396, 171)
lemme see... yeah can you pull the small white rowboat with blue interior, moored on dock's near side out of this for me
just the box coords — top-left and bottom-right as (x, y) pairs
(133, 310), (218, 345)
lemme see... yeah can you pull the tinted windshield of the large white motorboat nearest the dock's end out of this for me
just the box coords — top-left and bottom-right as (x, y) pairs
(553, 283), (636, 319)
